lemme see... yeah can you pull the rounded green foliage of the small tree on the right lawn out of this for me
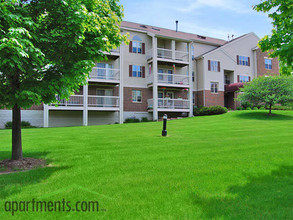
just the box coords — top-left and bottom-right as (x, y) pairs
(237, 76), (293, 113)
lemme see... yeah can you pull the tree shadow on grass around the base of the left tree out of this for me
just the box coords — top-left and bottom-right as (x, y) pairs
(0, 151), (71, 200)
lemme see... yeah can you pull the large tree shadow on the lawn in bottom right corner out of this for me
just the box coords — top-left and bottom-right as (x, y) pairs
(193, 166), (293, 219)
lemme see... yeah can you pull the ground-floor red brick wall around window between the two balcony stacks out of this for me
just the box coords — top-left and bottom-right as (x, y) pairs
(124, 87), (153, 112)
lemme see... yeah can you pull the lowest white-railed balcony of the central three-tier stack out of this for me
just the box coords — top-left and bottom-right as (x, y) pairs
(148, 98), (190, 112)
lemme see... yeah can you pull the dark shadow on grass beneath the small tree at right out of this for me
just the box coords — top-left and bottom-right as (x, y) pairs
(235, 112), (293, 121)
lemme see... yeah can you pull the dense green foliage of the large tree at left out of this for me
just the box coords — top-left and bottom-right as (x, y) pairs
(0, 0), (126, 108)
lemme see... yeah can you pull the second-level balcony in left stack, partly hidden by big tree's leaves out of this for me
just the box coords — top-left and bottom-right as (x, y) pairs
(89, 67), (120, 84)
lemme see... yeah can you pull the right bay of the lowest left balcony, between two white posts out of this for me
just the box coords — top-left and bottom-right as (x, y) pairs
(88, 95), (120, 111)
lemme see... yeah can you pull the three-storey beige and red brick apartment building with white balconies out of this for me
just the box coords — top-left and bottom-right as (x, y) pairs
(0, 22), (279, 128)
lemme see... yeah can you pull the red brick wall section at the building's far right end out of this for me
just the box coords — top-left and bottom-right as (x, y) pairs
(256, 49), (280, 76)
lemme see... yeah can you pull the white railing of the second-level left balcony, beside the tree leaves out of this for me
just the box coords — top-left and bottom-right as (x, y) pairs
(90, 67), (120, 81)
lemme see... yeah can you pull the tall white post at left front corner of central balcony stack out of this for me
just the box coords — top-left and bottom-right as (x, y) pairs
(153, 36), (158, 121)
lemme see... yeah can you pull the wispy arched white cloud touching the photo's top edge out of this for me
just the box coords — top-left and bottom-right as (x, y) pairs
(177, 0), (253, 14)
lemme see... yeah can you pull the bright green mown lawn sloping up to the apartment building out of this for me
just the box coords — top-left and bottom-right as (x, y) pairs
(0, 111), (293, 219)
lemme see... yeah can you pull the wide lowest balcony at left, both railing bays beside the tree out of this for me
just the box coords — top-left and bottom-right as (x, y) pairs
(48, 95), (120, 111)
